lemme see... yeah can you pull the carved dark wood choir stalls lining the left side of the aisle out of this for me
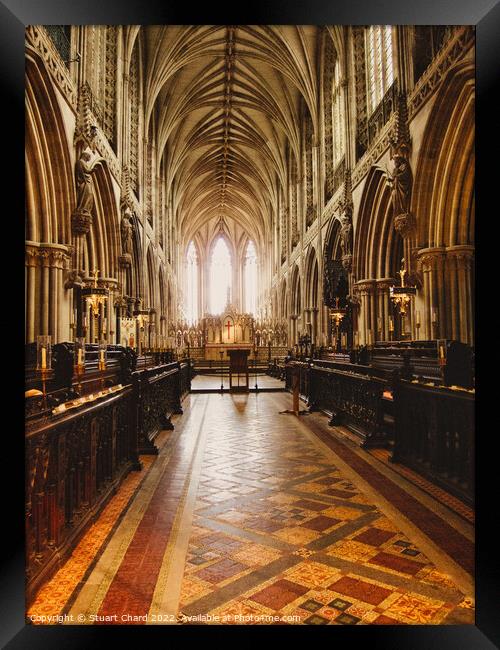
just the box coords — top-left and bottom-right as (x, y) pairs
(26, 344), (191, 603)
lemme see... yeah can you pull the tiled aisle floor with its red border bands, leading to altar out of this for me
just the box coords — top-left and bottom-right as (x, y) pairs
(68, 393), (474, 624)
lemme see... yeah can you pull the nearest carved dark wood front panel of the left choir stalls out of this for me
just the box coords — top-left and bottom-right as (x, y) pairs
(26, 387), (140, 600)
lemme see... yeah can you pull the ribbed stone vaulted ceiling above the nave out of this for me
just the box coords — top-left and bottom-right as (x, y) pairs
(125, 26), (328, 256)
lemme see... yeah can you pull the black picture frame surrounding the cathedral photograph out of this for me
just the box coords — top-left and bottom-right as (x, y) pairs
(6, 0), (500, 650)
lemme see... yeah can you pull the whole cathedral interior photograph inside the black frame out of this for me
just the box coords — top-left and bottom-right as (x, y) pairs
(25, 25), (475, 625)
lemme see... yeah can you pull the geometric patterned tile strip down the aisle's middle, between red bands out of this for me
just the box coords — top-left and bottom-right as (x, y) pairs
(175, 396), (474, 625)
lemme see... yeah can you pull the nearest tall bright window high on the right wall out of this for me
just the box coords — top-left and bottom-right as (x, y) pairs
(366, 25), (394, 115)
